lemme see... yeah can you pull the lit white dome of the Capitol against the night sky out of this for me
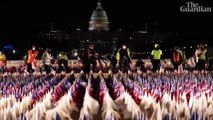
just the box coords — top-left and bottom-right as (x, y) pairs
(89, 1), (109, 31)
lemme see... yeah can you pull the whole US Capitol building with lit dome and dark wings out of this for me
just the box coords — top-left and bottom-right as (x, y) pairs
(38, 1), (176, 57)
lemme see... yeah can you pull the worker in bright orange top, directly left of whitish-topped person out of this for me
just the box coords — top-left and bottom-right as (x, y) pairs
(27, 45), (39, 73)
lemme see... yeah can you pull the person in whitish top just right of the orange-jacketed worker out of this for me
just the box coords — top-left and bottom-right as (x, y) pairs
(42, 48), (53, 74)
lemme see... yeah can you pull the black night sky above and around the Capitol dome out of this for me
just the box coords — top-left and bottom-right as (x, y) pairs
(0, 0), (213, 46)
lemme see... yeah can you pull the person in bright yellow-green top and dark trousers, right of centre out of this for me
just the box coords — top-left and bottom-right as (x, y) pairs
(151, 44), (163, 72)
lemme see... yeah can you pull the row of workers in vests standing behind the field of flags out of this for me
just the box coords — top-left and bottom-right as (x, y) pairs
(0, 43), (212, 74)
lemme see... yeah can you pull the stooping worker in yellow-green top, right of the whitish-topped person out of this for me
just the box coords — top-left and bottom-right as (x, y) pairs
(57, 52), (69, 72)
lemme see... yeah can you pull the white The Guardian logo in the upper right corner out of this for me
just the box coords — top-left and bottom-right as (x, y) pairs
(180, 2), (212, 12)
